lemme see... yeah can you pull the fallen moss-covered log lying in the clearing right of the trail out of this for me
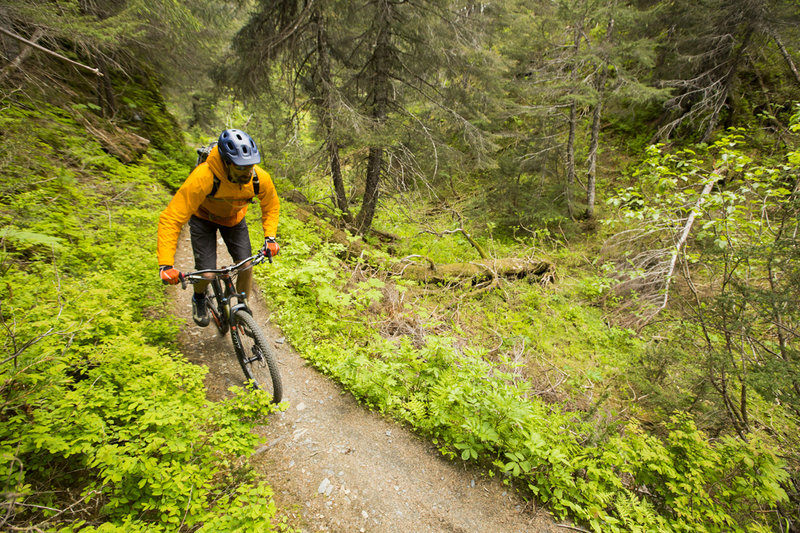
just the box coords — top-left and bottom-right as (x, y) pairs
(396, 257), (554, 283)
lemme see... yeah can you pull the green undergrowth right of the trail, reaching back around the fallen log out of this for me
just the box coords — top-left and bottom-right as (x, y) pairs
(258, 175), (789, 531)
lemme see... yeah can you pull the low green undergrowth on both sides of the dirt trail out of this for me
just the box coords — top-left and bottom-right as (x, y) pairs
(2, 89), (789, 531)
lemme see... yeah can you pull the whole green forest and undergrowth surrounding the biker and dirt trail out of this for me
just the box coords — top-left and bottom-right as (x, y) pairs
(0, 0), (800, 531)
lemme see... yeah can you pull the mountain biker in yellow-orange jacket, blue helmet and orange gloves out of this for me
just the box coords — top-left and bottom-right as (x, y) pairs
(158, 129), (280, 327)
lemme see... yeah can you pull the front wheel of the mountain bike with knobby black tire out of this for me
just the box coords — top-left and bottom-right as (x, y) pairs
(231, 309), (283, 403)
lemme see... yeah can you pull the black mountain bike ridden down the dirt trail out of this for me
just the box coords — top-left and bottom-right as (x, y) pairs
(181, 253), (283, 403)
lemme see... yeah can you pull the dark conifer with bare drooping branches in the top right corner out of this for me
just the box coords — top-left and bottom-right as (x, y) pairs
(651, 0), (800, 142)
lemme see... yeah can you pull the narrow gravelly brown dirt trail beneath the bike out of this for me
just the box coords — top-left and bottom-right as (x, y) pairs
(170, 232), (568, 533)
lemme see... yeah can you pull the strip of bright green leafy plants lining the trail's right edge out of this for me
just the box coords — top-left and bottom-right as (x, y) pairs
(256, 202), (787, 532)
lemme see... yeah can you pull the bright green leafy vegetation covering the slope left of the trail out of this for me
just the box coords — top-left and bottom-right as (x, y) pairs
(0, 98), (288, 532)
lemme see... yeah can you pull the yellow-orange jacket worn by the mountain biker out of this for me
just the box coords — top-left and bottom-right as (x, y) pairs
(158, 146), (280, 265)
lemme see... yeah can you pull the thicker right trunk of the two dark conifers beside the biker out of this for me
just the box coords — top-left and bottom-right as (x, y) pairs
(356, 0), (392, 235)
